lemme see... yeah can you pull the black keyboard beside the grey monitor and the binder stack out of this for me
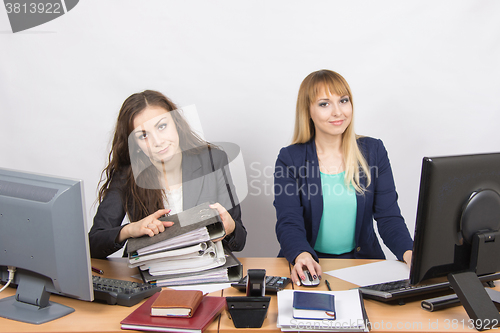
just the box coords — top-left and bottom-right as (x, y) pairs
(92, 275), (161, 306)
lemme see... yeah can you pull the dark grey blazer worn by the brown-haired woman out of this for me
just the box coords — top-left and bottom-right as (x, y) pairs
(89, 148), (247, 258)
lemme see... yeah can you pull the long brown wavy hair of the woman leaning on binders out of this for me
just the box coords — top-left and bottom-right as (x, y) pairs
(98, 90), (210, 222)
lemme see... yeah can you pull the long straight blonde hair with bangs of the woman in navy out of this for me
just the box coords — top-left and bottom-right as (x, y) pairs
(292, 69), (371, 193)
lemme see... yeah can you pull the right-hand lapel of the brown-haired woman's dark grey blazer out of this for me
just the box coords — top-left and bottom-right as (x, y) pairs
(182, 153), (205, 210)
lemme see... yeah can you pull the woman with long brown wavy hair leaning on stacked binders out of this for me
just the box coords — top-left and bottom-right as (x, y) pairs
(89, 90), (246, 258)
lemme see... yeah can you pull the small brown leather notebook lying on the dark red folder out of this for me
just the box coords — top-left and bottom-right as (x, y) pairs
(151, 289), (203, 318)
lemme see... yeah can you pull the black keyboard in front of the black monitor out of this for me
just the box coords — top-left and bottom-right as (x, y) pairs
(359, 273), (500, 302)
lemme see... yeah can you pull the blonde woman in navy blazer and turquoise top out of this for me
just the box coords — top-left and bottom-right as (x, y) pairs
(274, 70), (413, 285)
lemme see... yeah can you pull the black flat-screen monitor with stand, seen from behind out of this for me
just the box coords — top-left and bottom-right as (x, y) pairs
(410, 153), (500, 329)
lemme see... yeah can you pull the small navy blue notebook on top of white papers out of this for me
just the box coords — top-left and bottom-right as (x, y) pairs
(293, 291), (336, 320)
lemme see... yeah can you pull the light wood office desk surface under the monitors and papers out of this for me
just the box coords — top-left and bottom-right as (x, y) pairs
(0, 258), (500, 333)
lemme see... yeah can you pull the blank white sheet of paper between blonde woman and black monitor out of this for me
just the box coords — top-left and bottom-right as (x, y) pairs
(326, 260), (410, 286)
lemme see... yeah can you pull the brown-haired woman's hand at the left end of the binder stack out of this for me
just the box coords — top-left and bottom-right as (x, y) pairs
(117, 209), (174, 243)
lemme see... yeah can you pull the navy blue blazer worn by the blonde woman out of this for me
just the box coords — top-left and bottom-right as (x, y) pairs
(274, 137), (413, 263)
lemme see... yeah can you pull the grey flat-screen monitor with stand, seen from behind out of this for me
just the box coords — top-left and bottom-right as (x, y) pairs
(0, 168), (94, 324)
